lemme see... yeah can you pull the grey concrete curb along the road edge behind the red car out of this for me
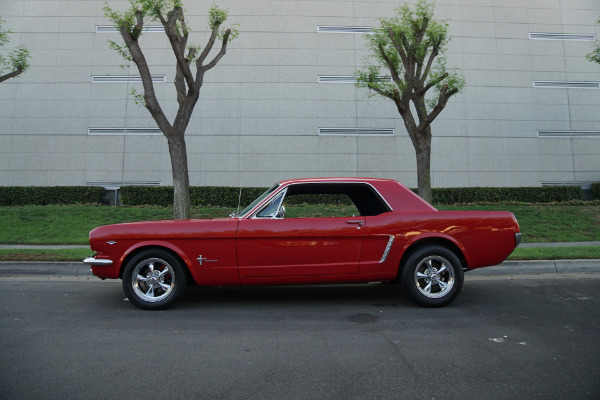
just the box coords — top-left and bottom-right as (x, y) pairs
(0, 259), (600, 277)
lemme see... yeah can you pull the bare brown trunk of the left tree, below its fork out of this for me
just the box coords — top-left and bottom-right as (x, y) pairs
(168, 134), (190, 219)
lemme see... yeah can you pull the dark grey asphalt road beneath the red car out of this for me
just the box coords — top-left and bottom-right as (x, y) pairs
(0, 274), (600, 400)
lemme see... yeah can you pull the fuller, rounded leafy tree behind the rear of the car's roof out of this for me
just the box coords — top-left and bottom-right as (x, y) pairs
(356, 0), (465, 201)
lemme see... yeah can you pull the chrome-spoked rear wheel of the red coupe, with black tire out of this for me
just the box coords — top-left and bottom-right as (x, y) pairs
(402, 245), (464, 307)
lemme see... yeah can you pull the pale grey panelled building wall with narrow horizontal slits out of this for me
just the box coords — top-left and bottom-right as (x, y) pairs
(0, 0), (600, 187)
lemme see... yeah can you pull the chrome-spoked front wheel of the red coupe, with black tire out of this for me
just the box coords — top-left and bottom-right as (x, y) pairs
(123, 249), (186, 310)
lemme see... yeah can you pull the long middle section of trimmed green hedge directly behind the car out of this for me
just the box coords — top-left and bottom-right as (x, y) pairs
(121, 186), (583, 207)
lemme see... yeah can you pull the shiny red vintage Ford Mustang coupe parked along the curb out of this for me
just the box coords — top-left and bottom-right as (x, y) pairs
(84, 178), (521, 309)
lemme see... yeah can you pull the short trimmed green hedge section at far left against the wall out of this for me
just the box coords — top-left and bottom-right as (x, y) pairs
(0, 186), (105, 206)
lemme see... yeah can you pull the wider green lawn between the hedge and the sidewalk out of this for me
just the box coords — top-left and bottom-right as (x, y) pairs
(0, 204), (600, 245)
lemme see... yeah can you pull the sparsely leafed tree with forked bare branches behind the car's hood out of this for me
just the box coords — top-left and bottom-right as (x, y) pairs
(104, 0), (237, 219)
